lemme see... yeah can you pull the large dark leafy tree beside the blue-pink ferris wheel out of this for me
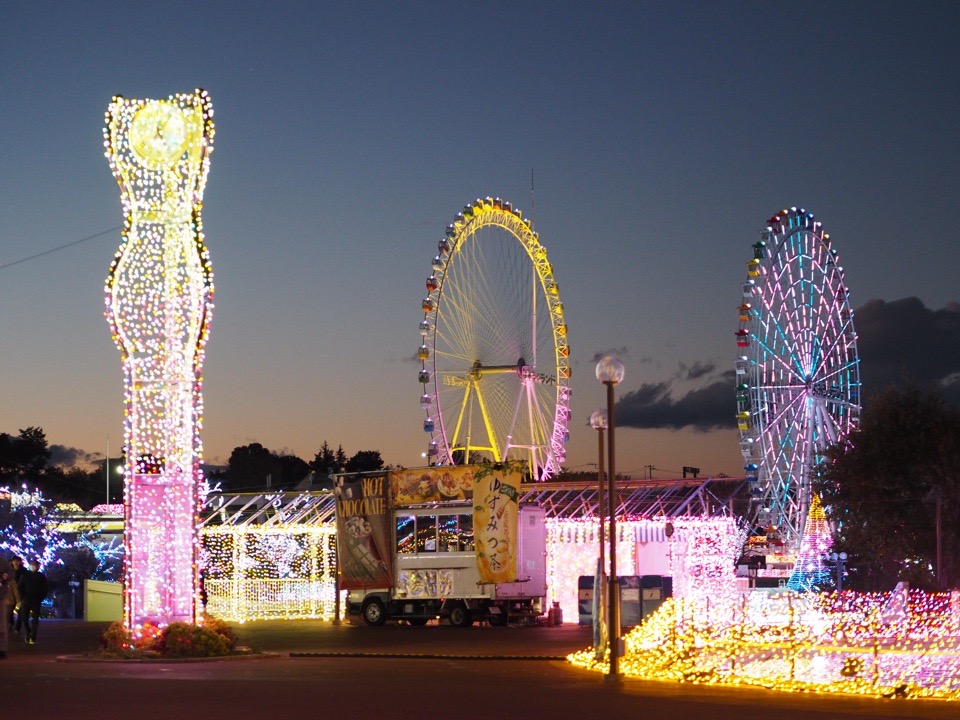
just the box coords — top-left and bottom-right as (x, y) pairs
(815, 387), (960, 591)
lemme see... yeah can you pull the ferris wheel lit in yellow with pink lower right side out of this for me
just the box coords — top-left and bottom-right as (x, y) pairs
(417, 197), (570, 480)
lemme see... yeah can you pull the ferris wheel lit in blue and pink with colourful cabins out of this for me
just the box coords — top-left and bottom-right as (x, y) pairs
(736, 208), (860, 550)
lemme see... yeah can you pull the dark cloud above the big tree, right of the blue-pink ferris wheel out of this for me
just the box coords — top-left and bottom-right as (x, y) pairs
(853, 297), (960, 403)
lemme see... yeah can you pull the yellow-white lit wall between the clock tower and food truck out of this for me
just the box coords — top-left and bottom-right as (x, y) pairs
(201, 523), (336, 622)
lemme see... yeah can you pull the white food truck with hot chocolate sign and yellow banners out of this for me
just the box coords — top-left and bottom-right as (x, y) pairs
(335, 466), (547, 627)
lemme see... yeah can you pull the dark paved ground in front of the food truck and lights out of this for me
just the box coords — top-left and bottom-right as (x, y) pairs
(0, 621), (960, 720)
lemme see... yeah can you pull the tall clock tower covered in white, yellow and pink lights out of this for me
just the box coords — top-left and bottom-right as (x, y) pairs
(103, 90), (214, 636)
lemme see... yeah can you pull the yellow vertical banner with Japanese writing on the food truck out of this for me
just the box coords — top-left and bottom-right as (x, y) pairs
(473, 463), (523, 583)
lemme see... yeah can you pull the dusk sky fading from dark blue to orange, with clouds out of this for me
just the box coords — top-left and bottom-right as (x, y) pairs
(0, 0), (960, 477)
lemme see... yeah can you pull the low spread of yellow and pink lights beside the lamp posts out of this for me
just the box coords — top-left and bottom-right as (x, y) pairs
(568, 590), (960, 700)
